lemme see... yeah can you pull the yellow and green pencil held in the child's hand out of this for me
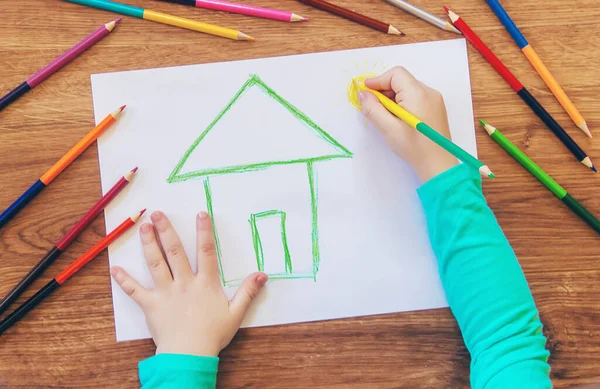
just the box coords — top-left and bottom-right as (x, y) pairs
(358, 82), (496, 178)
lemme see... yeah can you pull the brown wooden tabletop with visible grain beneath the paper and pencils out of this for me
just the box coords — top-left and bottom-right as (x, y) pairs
(0, 0), (600, 389)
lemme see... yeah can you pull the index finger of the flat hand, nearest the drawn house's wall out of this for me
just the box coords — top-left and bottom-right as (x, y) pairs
(196, 212), (219, 282)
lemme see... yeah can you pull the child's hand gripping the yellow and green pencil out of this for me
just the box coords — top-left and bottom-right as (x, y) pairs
(359, 67), (458, 182)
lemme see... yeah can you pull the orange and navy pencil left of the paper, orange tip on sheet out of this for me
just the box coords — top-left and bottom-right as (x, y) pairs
(0, 106), (125, 228)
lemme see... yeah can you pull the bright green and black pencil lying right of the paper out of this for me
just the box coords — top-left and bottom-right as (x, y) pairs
(480, 120), (600, 234)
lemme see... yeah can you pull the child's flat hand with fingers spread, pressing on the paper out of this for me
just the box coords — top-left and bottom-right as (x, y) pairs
(111, 212), (267, 356)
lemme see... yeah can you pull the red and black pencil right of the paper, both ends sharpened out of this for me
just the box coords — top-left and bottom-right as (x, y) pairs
(444, 7), (596, 172)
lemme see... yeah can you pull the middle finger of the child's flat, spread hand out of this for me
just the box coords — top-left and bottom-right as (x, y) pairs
(150, 212), (193, 280)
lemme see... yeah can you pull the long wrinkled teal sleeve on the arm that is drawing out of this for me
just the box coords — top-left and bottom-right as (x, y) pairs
(419, 164), (552, 389)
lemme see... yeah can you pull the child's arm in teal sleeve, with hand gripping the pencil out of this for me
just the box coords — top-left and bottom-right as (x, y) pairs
(360, 68), (552, 389)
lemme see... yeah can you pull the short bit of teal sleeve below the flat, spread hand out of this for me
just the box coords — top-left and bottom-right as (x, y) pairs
(138, 354), (219, 389)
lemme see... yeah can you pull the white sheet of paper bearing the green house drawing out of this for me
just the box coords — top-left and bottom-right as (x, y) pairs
(92, 39), (476, 341)
